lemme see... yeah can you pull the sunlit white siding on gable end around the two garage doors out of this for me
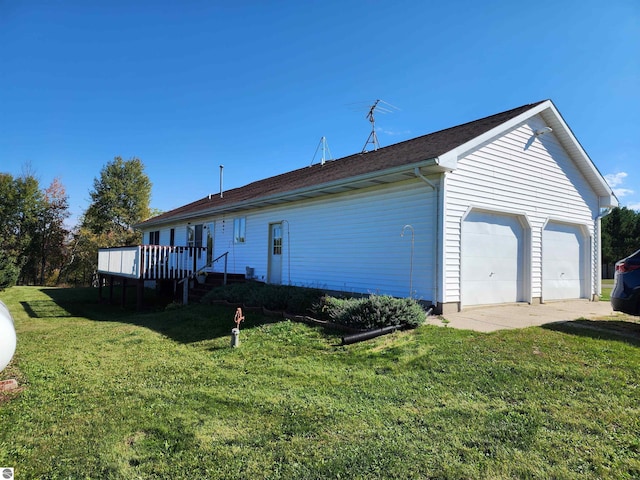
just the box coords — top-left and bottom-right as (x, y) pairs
(444, 116), (598, 302)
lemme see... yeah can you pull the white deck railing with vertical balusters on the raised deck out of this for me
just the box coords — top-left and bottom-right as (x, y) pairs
(98, 245), (207, 280)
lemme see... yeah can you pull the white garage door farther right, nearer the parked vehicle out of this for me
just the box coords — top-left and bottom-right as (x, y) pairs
(542, 222), (586, 300)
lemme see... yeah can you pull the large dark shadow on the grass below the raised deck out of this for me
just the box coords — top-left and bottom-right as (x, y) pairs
(36, 288), (282, 343)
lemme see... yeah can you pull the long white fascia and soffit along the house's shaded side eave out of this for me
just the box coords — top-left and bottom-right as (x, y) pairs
(139, 158), (439, 230)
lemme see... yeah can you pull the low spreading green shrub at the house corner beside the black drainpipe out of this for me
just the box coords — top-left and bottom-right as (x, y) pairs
(316, 295), (425, 330)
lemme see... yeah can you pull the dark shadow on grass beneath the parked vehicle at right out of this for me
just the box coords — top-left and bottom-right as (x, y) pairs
(542, 320), (640, 346)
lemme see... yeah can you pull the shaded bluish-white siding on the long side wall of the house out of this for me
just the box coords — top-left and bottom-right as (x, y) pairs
(222, 180), (435, 300)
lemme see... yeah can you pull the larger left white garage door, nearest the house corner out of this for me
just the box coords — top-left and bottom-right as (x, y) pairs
(461, 212), (524, 306)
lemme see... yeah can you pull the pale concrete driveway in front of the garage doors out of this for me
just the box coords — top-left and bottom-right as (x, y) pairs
(429, 300), (617, 332)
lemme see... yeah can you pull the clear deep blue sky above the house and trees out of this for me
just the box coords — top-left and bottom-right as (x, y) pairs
(0, 0), (640, 227)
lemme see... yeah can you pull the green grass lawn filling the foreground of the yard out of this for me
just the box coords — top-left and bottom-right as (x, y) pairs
(0, 287), (640, 479)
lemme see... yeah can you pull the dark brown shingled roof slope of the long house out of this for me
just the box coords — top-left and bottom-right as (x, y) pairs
(138, 102), (542, 227)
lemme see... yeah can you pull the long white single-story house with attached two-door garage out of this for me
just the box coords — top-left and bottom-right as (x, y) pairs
(100, 100), (617, 313)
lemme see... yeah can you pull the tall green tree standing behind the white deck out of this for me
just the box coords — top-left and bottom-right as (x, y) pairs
(82, 157), (151, 247)
